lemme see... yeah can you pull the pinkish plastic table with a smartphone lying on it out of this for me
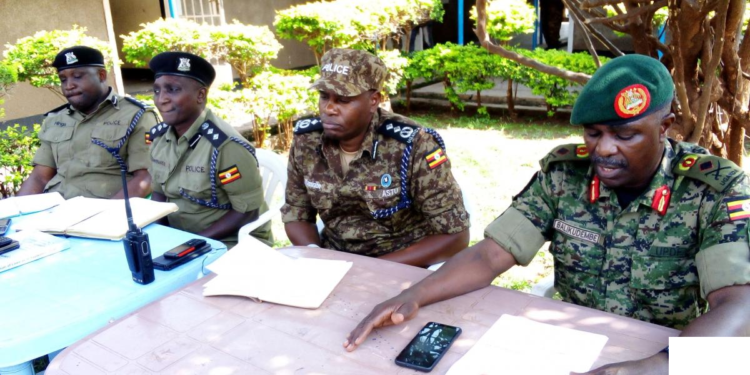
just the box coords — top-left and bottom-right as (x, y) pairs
(46, 248), (679, 375)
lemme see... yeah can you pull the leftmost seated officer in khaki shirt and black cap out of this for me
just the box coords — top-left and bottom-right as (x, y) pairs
(18, 46), (158, 199)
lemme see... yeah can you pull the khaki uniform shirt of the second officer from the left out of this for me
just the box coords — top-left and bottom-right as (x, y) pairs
(149, 110), (273, 245)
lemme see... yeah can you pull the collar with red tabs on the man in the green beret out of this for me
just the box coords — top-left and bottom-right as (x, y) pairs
(592, 139), (676, 213)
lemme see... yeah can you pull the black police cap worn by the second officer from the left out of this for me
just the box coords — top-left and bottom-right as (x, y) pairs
(148, 52), (216, 87)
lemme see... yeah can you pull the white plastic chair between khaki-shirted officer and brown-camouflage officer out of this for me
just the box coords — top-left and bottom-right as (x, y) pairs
(237, 148), (287, 242)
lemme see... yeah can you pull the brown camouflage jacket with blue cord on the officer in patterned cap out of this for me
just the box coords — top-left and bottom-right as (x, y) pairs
(281, 110), (469, 256)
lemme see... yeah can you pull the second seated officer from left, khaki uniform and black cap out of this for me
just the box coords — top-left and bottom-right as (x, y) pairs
(149, 52), (273, 248)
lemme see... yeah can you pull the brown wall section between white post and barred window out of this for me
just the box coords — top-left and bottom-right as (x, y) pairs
(109, 0), (161, 68)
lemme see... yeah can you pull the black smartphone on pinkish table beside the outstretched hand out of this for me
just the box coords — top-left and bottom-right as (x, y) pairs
(396, 322), (461, 372)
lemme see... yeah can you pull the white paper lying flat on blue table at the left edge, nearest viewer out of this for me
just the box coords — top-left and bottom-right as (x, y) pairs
(0, 230), (70, 272)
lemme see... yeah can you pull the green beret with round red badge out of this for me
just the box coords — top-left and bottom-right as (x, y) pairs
(570, 54), (674, 126)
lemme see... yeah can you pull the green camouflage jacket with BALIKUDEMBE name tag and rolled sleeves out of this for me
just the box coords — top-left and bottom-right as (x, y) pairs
(485, 140), (750, 328)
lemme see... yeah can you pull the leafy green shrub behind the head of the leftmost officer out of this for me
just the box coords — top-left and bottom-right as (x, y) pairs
(3, 26), (119, 95)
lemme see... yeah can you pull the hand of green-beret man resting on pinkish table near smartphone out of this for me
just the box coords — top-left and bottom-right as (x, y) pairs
(344, 290), (419, 352)
